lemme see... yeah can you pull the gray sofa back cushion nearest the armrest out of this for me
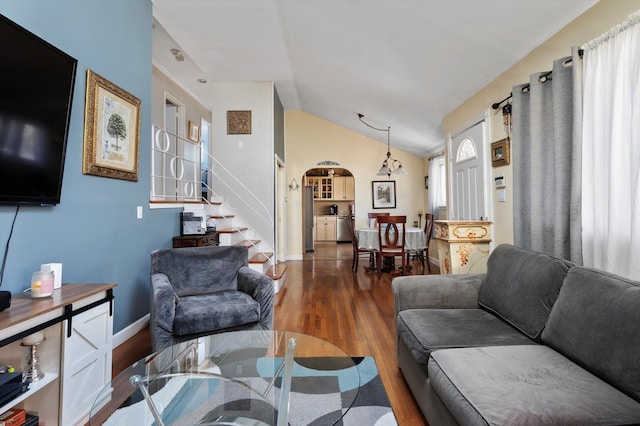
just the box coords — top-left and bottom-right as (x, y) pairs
(478, 244), (573, 341)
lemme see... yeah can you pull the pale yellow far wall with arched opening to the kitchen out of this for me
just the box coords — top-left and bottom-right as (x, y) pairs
(284, 111), (425, 259)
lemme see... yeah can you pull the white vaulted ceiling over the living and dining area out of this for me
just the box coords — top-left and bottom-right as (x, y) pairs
(153, 0), (597, 157)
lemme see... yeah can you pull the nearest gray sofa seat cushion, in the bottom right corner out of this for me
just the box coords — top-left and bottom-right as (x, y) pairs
(429, 345), (640, 425)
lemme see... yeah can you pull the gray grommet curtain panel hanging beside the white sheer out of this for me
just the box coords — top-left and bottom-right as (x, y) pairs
(511, 49), (582, 264)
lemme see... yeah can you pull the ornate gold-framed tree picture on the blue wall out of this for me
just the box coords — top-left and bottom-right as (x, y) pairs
(82, 70), (140, 181)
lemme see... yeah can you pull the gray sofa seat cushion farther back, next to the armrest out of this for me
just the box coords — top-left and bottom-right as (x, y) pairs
(397, 309), (534, 371)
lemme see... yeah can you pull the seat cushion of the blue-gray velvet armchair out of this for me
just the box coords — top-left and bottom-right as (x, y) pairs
(173, 290), (260, 336)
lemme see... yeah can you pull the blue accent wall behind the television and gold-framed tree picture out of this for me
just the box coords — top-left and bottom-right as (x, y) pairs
(0, 0), (179, 333)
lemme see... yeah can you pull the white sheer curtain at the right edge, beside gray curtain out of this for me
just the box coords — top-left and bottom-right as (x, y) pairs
(582, 13), (640, 280)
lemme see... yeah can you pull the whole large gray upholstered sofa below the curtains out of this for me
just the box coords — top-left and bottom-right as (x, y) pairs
(392, 245), (640, 426)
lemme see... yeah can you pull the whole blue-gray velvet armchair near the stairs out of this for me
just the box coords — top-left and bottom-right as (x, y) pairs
(150, 246), (274, 351)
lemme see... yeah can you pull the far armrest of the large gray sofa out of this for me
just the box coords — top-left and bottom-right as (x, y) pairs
(391, 274), (485, 316)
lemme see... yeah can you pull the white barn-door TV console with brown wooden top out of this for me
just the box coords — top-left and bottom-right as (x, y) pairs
(0, 284), (116, 426)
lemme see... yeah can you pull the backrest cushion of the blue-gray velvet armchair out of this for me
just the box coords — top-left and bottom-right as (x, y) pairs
(151, 246), (248, 297)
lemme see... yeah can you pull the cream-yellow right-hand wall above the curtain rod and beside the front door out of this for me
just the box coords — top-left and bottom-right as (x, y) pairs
(443, 0), (640, 245)
